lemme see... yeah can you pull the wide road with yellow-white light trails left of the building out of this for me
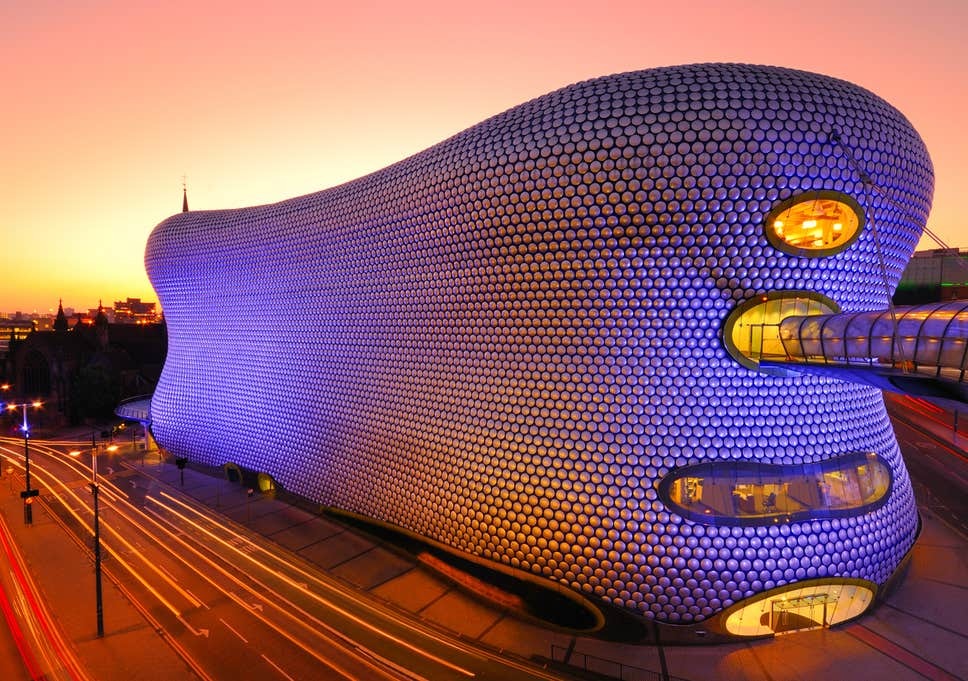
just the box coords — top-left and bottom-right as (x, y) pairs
(0, 441), (576, 680)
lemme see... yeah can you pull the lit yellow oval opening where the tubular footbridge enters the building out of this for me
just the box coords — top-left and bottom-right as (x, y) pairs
(723, 291), (840, 375)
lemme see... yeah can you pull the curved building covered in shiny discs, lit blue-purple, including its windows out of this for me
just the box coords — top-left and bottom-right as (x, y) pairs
(145, 64), (933, 635)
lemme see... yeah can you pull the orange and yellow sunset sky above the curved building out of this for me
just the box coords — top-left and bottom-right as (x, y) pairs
(0, 0), (968, 312)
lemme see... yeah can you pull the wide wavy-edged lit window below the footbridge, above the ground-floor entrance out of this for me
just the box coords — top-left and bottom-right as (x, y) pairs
(659, 452), (891, 525)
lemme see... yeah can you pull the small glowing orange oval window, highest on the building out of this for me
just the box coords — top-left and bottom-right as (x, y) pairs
(766, 191), (864, 257)
